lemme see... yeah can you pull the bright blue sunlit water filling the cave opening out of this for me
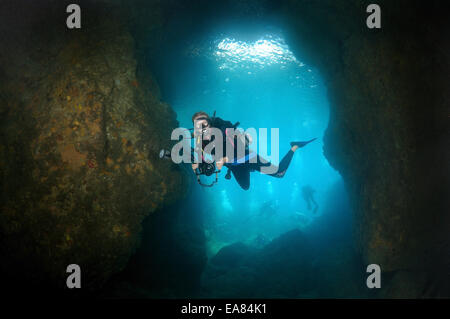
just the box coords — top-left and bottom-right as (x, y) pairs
(156, 28), (341, 255)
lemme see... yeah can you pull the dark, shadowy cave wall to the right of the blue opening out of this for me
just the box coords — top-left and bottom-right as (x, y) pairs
(284, 0), (449, 297)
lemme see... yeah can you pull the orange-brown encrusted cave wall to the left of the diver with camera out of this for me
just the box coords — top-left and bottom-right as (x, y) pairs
(0, 1), (186, 293)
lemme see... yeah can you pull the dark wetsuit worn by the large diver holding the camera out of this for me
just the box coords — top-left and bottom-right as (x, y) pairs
(210, 117), (294, 190)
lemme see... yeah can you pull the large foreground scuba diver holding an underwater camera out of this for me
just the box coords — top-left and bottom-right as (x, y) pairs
(192, 111), (315, 190)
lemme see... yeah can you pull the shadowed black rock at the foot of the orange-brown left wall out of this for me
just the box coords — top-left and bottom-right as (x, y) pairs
(101, 188), (206, 298)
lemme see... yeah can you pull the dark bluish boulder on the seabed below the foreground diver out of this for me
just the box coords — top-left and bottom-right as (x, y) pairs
(203, 230), (314, 298)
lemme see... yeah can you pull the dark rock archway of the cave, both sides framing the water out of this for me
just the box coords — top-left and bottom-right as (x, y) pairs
(0, 0), (450, 297)
